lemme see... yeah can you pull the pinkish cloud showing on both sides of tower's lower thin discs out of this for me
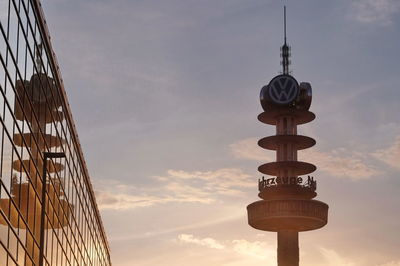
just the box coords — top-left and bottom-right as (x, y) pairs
(230, 138), (380, 180)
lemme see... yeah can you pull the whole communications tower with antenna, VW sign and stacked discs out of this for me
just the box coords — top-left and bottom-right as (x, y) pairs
(247, 7), (328, 266)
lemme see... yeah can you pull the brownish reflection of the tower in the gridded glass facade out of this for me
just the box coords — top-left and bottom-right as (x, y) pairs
(0, 64), (72, 263)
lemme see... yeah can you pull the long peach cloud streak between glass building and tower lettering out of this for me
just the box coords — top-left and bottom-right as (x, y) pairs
(95, 168), (256, 210)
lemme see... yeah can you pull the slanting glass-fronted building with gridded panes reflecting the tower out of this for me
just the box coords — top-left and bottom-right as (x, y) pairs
(0, 0), (111, 266)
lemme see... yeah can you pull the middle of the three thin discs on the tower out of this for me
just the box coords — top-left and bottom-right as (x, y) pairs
(258, 135), (315, 150)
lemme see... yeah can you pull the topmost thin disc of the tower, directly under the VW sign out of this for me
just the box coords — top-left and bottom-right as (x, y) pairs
(257, 108), (315, 125)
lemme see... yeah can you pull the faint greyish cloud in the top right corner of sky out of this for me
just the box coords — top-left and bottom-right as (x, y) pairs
(351, 0), (400, 26)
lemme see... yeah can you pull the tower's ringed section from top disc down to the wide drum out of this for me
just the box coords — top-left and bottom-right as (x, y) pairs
(247, 107), (328, 232)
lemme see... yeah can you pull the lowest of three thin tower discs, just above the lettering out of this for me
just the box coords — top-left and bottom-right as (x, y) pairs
(258, 161), (317, 176)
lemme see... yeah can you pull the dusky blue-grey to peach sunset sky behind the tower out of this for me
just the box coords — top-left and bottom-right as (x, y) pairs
(38, 0), (400, 266)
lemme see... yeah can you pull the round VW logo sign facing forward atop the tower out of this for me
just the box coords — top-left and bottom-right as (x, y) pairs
(268, 75), (299, 104)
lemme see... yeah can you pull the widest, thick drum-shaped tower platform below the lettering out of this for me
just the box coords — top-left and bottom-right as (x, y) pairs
(247, 199), (329, 232)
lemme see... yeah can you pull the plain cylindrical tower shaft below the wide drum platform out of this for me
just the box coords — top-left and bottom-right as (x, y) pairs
(278, 230), (299, 266)
